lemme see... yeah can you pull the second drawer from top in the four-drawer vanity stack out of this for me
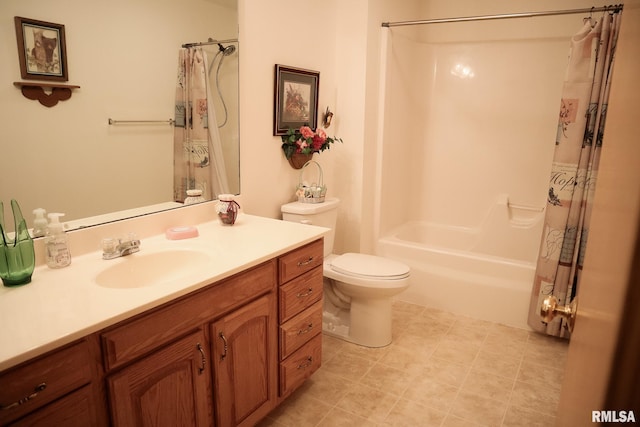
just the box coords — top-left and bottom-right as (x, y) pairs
(279, 265), (322, 323)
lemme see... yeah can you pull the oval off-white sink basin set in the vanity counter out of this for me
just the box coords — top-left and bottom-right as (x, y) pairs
(95, 250), (211, 289)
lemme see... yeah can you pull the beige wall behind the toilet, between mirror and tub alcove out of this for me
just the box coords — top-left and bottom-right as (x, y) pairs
(239, 0), (360, 254)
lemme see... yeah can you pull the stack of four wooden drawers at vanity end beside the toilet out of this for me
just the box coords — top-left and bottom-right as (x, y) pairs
(278, 240), (324, 399)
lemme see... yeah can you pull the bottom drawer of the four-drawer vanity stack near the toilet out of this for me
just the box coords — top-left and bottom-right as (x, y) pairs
(280, 334), (322, 397)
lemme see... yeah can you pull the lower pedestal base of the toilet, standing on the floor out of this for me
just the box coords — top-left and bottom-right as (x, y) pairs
(322, 298), (392, 348)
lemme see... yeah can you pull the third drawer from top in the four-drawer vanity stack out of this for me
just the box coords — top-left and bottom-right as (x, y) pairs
(280, 301), (322, 360)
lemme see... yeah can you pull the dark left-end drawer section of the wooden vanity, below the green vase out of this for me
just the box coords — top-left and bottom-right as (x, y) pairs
(0, 339), (107, 426)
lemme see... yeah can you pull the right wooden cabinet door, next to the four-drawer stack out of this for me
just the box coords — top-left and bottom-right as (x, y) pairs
(211, 294), (278, 427)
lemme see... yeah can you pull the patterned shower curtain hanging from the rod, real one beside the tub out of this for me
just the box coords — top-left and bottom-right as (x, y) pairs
(528, 12), (620, 338)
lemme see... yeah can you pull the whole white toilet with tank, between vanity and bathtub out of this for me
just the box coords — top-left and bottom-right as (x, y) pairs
(281, 198), (410, 347)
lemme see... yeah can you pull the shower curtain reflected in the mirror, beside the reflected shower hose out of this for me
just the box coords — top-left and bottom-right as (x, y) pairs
(173, 47), (229, 202)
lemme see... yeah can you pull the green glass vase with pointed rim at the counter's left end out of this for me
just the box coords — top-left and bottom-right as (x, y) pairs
(0, 200), (36, 286)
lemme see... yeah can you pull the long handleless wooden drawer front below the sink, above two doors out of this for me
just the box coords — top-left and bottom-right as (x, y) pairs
(102, 260), (276, 370)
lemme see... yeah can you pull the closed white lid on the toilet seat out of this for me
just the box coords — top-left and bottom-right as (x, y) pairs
(331, 253), (409, 279)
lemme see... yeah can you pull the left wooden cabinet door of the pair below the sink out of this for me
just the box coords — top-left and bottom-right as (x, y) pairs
(107, 331), (213, 427)
